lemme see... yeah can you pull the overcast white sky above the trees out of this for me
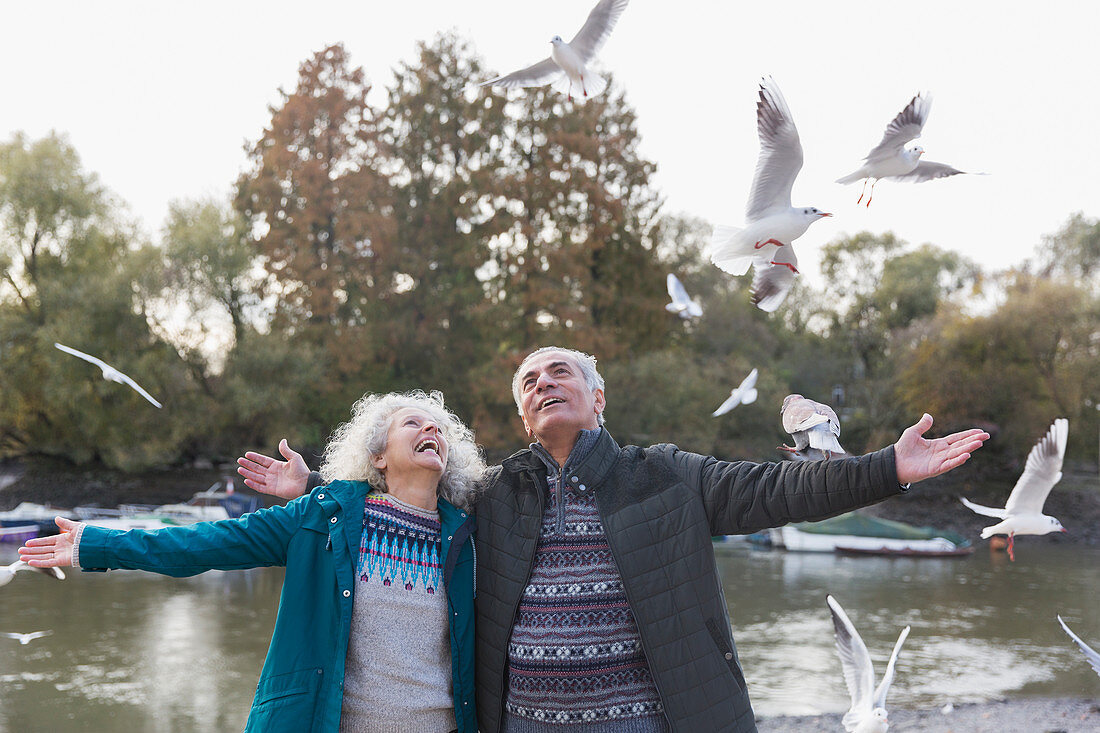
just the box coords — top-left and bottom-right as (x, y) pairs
(0, 0), (1100, 281)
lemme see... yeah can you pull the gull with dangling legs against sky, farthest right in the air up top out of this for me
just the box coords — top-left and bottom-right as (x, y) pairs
(836, 94), (966, 206)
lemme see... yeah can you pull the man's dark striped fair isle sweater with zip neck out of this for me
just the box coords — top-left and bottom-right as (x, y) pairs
(504, 430), (669, 732)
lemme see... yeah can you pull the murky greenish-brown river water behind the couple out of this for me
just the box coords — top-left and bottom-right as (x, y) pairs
(0, 537), (1100, 733)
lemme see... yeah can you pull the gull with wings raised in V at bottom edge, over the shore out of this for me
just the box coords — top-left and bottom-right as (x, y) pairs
(825, 595), (909, 733)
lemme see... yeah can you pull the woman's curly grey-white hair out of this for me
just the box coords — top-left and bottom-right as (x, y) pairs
(321, 390), (485, 511)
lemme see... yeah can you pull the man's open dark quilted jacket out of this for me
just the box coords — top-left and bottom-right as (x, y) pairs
(476, 430), (902, 733)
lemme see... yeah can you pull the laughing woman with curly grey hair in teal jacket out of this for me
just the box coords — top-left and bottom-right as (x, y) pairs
(20, 392), (485, 733)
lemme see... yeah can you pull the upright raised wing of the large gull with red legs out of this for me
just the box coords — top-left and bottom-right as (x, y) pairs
(745, 77), (802, 220)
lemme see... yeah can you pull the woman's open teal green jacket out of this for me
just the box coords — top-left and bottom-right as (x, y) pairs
(78, 481), (477, 733)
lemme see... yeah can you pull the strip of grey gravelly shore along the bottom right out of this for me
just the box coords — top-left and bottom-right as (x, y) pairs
(757, 695), (1100, 733)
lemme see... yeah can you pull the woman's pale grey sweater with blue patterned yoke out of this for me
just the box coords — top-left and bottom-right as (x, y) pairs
(340, 492), (457, 733)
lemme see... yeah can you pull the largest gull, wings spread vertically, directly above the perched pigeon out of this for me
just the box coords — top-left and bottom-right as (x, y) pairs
(710, 77), (833, 313)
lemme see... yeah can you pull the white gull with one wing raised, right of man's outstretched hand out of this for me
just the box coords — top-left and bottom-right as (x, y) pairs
(963, 417), (1069, 560)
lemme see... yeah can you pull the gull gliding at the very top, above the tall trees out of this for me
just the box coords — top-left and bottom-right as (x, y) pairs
(477, 0), (630, 100)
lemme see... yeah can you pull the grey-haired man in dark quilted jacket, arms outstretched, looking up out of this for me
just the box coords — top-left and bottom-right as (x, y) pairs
(242, 347), (989, 733)
